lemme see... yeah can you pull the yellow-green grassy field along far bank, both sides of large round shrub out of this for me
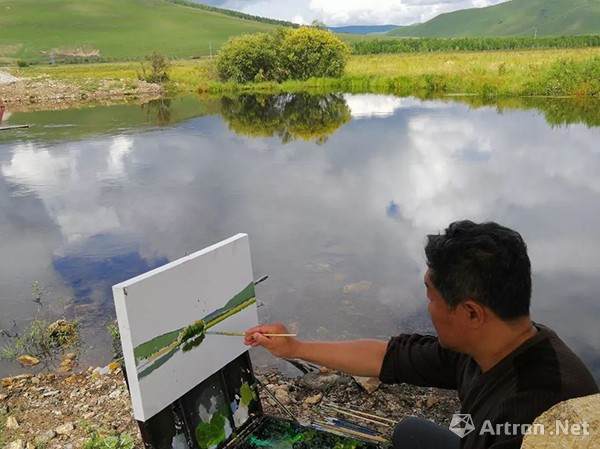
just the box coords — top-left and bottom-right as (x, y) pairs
(10, 48), (600, 97)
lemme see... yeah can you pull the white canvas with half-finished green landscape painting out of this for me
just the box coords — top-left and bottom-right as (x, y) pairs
(113, 234), (258, 421)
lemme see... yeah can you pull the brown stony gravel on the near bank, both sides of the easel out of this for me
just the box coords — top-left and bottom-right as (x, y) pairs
(0, 364), (459, 449)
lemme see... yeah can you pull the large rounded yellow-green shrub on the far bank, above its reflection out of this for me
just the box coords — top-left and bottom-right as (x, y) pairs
(217, 27), (350, 83)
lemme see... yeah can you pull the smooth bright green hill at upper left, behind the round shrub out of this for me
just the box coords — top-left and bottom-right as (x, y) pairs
(0, 0), (291, 62)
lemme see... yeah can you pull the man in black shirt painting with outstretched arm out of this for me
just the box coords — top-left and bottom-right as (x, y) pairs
(245, 221), (598, 449)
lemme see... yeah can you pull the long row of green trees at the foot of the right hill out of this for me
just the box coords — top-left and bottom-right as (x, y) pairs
(352, 34), (600, 55)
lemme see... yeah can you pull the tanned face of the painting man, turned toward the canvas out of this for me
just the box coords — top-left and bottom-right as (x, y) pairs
(425, 270), (461, 351)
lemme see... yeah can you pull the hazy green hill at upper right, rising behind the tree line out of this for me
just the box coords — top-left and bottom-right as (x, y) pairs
(387, 0), (600, 37)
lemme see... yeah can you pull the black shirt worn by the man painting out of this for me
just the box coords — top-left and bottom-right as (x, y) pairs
(379, 324), (598, 449)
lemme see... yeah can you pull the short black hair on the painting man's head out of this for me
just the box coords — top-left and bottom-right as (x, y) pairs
(425, 220), (531, 321)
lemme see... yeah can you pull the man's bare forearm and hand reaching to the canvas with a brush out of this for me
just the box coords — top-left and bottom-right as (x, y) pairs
(244, 323), (387, 377)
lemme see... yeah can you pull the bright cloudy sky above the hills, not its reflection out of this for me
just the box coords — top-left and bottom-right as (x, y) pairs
(194, 0), (507, 26)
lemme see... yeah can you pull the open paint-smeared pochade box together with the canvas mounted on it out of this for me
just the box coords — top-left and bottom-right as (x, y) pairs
(113, 234), (383, 449)
